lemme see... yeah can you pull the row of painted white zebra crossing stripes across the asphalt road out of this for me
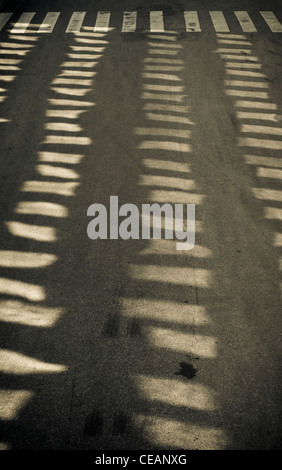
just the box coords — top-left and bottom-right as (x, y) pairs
(0, 10), (282, 34)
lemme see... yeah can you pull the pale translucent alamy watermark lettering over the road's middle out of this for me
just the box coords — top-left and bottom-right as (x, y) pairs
(87, 196), (195, 251)
